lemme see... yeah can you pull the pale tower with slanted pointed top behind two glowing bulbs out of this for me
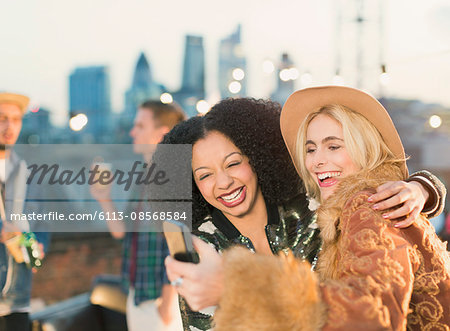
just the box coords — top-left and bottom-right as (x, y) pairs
(219, 25), (247, 98)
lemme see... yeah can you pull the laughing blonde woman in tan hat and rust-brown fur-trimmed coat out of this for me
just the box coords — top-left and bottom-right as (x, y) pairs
(215, 87), (450, 331)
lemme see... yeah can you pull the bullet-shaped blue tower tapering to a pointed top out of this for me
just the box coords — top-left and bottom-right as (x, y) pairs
(124, 52), (165, 119)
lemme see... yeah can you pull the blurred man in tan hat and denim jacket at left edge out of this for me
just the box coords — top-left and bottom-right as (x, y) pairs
(0, 93), (49, 331)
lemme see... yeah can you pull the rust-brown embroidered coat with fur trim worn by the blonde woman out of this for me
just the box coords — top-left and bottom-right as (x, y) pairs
(215, 165), (450, 331)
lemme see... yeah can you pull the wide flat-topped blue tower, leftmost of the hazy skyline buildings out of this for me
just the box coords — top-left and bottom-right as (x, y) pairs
(69, 66), (111, 141)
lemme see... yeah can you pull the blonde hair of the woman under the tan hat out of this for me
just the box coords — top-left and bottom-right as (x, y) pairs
(295, 104), (402, 201)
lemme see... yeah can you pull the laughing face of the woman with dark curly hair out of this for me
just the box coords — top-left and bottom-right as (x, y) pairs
(192, 131), (264, 220)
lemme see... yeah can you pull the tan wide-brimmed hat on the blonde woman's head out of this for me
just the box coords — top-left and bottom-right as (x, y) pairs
(280, 86), (408, 177)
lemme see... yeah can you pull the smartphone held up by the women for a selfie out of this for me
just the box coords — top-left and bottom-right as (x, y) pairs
(163, 221), (200, 263)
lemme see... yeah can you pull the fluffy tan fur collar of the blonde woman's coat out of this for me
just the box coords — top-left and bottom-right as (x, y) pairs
(317, 162), (404, 249)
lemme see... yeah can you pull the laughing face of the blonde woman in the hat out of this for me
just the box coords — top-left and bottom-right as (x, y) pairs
(305, 115), (359, 200)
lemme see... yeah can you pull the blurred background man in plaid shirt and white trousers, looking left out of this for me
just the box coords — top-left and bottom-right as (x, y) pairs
(91, 101), (185, 331)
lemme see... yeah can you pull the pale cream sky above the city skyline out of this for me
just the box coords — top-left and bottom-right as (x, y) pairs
(0, 0), (450, 124)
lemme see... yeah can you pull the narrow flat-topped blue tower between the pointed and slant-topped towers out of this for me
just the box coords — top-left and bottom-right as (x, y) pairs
(174, 35), (205, 116)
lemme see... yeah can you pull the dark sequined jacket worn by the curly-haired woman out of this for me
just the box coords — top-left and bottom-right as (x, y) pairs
(180, 195), (321, 331)
